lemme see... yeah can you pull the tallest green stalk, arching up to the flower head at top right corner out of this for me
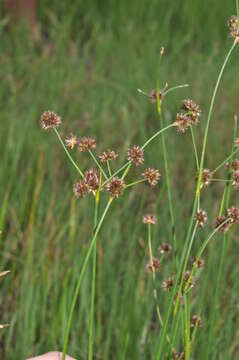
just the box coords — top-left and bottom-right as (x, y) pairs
(156, 44), (235, 360)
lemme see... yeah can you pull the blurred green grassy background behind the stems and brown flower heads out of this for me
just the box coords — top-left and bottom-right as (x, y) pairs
(0, 0), (239, 360)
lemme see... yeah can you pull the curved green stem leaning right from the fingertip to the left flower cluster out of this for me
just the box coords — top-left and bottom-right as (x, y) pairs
(62, 198), (113, 360)
